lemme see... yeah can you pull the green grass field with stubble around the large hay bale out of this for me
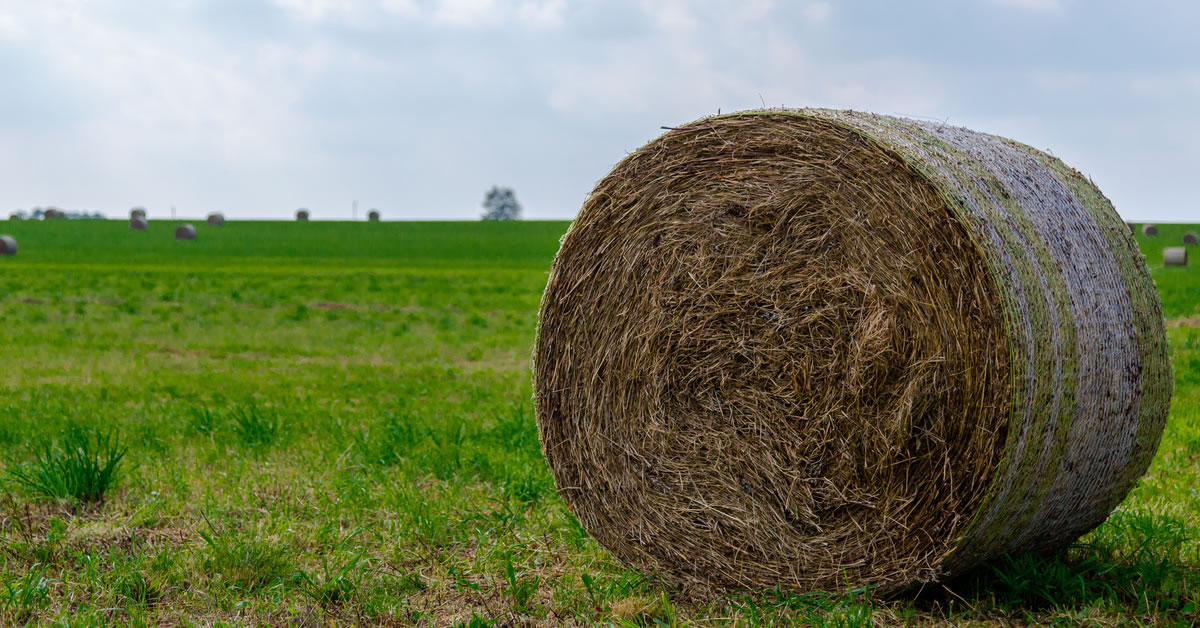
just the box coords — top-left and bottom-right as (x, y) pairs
(0, 221), (1200, 626)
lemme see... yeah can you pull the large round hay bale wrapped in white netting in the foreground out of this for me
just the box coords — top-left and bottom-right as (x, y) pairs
(534, 109), (1171, 591)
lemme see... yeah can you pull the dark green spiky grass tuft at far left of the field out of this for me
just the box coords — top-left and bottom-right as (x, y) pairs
(8, 425), (128, 503)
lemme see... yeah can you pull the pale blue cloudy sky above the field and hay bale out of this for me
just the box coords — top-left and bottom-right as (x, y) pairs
(0, 0), (1200, 222)
